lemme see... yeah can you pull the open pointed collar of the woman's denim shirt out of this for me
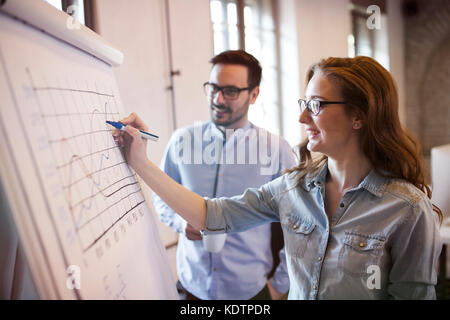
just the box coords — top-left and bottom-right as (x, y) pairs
(305, 162), (388, 197)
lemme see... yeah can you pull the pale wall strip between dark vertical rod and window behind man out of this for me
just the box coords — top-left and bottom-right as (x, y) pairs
(168, 0), (214, 127)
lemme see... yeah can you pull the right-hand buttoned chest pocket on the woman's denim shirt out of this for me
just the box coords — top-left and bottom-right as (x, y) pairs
(338, 232), (385, 277)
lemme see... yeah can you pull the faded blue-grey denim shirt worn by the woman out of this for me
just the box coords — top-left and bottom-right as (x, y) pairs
(205, 165), (442, 299)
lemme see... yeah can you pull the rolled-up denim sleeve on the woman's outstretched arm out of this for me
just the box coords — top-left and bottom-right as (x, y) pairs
(204, 179), (279, 234)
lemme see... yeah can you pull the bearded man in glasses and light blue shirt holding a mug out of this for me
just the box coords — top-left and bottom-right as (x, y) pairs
(153, 50), (295, 300)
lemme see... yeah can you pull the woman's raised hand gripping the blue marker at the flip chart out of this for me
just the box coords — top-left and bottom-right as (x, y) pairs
(113, 112), (148, 172)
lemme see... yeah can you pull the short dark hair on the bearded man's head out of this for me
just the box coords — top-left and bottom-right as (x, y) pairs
(209, 50), (262, 89)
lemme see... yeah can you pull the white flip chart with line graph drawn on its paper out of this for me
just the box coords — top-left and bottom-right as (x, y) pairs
(0, 6), (178, 299)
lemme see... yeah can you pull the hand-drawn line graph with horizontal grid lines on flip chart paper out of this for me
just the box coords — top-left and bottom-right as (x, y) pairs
(26, 68), (145, 252)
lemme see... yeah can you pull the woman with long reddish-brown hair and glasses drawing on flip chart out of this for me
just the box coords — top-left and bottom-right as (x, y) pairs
(114, 57), (442, 299)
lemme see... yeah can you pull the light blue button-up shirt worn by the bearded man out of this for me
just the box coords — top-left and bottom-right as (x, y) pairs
(153, 122), (295, 299)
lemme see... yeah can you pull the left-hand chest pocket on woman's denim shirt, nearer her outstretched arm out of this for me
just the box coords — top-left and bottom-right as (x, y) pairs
(281, 215), (316, 258)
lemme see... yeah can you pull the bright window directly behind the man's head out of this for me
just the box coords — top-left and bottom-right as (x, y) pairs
(210, 0), (281, 134)
